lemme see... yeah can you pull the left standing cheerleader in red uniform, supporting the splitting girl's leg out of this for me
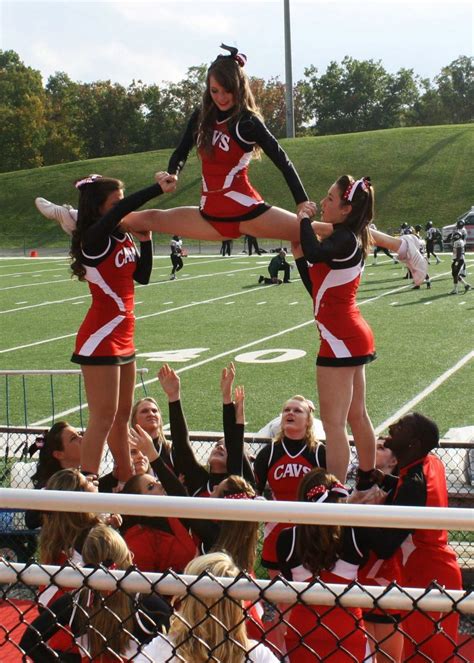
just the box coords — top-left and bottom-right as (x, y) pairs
(71, 173), (174, 482)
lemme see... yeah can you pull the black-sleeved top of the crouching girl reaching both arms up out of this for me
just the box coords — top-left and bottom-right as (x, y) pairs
(169, 401), (255, 497)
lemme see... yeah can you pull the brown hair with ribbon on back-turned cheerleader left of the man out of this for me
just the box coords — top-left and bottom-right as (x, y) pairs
(296, 467), (342, 576)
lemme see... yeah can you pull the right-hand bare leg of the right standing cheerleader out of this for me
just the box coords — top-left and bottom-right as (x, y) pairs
(347, 366), (376, 470)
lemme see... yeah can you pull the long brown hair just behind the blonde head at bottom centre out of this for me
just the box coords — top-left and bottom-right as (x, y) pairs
(212, 474), (259, 571)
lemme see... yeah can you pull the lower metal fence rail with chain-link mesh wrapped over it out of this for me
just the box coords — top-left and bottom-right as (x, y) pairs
(0, 561), (474, 613)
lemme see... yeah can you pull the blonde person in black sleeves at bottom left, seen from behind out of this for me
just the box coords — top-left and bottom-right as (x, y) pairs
(20, 525), (172, 663)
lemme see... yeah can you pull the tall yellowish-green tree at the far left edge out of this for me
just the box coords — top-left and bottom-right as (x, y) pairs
(0, 51), (46, 172)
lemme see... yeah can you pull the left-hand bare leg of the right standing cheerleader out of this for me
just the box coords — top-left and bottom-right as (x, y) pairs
(316, 366), (358, 483)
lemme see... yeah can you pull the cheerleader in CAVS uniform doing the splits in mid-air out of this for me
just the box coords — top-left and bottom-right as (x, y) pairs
(119, 45), (315, 241)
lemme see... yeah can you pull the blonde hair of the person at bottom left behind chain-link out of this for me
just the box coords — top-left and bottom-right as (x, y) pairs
(75, 525), (135, 660)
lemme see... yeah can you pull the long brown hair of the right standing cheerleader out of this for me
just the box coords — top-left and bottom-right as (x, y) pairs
(336, 175), (375, 257)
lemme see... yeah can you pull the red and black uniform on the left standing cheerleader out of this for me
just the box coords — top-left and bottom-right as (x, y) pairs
(71, 184), (163, 365)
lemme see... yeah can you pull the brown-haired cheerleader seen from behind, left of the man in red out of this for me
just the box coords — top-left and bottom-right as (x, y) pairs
(277, 469), (372, 663)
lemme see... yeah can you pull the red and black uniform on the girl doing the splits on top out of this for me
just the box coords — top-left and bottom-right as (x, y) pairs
(168, 109), (308, 238)
